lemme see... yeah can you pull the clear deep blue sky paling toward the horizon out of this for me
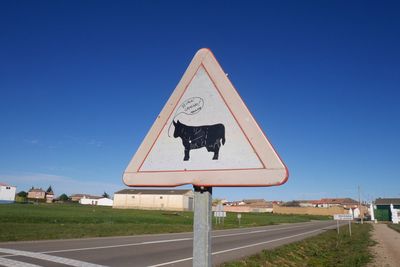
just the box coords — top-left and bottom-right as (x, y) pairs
(0, 0), (400, 203)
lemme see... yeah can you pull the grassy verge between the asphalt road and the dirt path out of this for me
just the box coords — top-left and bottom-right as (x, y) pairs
(222, 224), (375, 267)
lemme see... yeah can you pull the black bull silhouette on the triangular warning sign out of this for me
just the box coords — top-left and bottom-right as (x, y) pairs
(173, 120), (225, 161)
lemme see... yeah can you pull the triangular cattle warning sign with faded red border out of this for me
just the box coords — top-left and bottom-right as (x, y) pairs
(123, 49), (288, 187)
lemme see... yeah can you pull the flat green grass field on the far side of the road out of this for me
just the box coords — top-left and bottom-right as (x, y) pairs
(0, 204), (329, 242)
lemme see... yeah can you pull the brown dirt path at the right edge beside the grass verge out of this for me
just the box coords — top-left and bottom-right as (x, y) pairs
(369, 224), (400, 267)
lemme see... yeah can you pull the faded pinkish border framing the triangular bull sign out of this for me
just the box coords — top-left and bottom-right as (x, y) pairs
(123, 48), (289, 187)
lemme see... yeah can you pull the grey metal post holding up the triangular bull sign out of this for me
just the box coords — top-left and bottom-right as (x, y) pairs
(193, 186), (212, 267)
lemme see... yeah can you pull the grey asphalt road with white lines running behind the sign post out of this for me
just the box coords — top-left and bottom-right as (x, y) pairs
(0, 221), (336, 267)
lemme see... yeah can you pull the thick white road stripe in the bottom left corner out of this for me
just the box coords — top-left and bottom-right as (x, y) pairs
(0, 248), (104, 267)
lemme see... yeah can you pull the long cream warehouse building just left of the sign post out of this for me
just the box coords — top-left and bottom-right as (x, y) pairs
(113, 189), (194, 211)
